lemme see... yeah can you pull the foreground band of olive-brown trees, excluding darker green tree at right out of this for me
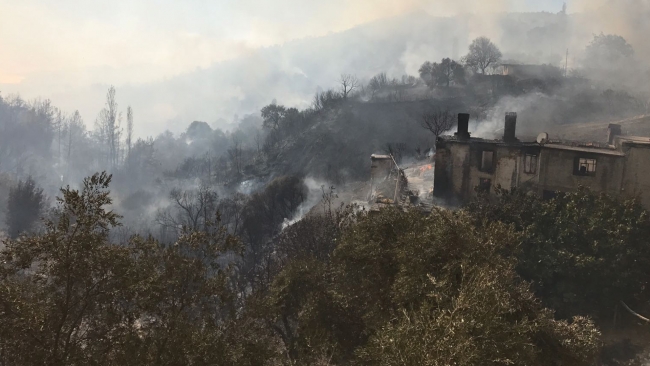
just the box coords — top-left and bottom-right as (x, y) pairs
(0, 174), (612, 365)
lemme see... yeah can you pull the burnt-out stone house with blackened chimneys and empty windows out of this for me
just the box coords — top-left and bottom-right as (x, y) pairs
(433, 113), (650, 208)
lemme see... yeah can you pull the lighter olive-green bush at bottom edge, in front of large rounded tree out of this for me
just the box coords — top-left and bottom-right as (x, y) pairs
(359, 267), (600, 366)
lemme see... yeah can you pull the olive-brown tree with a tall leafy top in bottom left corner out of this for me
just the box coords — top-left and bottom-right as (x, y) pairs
(0, 174), (135, 365)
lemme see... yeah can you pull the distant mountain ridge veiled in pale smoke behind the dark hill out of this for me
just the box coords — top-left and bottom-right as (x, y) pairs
(0, 13), (588, 137)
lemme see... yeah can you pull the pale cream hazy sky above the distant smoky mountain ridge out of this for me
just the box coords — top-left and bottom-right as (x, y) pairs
(0, 0), (562, 88)
